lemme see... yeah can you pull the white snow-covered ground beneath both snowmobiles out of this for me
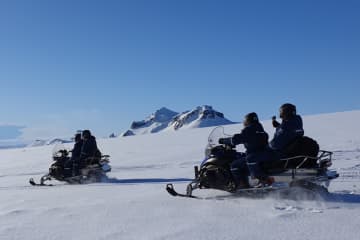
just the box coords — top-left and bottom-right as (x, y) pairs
(0, 111), (360, 240)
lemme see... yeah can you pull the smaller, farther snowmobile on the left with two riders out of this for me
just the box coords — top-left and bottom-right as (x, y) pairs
(29, 144), (111, 186)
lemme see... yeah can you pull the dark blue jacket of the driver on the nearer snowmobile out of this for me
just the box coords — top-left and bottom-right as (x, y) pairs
(231, 123), (269, 153)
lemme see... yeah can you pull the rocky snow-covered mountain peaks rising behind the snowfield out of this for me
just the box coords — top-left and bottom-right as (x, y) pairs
(121, 105), (233, 136)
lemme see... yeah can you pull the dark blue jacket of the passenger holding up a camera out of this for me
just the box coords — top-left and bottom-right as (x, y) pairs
(270, 115), (304, 151)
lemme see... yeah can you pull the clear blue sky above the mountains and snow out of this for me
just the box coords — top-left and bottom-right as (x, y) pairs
(0, 0), (360, 142)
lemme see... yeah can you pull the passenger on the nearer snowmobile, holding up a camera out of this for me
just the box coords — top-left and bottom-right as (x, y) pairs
(269, 103), (304, 157)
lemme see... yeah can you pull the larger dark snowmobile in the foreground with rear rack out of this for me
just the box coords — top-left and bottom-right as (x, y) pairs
(166, 126), (339, 198)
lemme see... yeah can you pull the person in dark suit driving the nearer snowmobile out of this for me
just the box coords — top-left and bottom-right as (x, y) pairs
(219, 112), (275, 188)
